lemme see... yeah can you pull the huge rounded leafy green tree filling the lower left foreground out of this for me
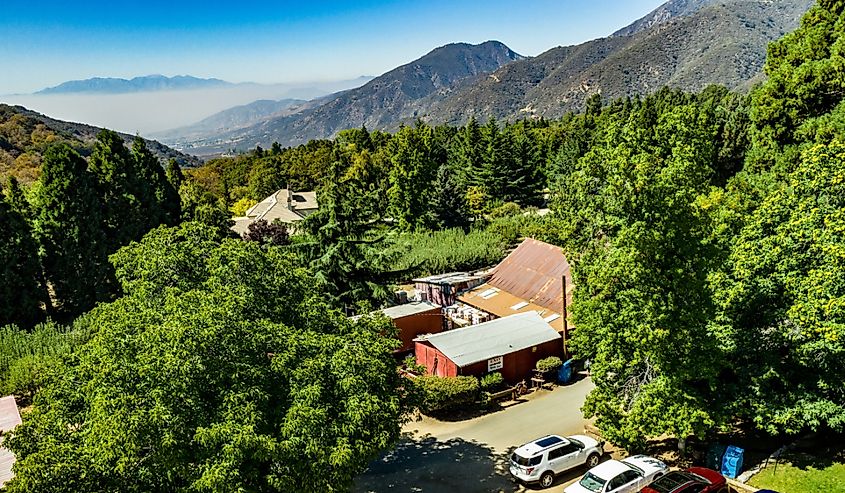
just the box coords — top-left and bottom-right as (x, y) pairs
(4, 224), (404, 493)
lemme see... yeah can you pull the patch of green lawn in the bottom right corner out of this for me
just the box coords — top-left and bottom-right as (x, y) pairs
(749, 454), (845, 493)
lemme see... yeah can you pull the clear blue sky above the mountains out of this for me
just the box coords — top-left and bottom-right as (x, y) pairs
(0, 0), (665, 94)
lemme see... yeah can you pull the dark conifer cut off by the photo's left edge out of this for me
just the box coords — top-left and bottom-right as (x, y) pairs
(0, 181), (47, 328)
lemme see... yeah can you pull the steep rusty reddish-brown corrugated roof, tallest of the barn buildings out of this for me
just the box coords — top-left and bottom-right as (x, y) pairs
(487, 238), (572, 313)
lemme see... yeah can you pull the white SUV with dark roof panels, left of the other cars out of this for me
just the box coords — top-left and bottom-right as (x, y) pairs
(510, 435), (604, 488)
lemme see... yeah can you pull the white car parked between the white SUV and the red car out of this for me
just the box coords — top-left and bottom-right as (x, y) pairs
(563, 455), (669, 493)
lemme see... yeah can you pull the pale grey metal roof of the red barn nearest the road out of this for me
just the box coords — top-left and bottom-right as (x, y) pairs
(417, 312), (560, 367)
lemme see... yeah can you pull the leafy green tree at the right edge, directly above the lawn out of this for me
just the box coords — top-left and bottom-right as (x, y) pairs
(711, 142), (845, 433)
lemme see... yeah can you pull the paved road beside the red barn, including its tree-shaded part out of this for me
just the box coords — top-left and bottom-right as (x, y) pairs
(354, 380), (593, 493)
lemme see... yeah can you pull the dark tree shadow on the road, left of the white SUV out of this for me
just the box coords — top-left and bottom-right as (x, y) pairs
(353, 437), (518, 493)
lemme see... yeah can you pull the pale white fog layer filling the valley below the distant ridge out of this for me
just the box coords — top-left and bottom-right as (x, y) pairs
(0, 78), (369, 136)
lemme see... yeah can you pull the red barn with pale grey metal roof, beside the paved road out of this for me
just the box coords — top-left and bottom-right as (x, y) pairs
(414, 312), (561, 382)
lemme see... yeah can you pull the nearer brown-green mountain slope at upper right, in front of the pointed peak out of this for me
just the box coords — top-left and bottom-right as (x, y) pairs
(421, 0), (813, 123)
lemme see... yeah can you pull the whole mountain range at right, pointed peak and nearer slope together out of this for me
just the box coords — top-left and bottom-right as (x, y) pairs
(162, 0), (814, 155)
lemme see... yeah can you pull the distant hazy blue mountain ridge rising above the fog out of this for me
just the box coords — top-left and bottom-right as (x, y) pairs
(35, 75), (234, 94)
